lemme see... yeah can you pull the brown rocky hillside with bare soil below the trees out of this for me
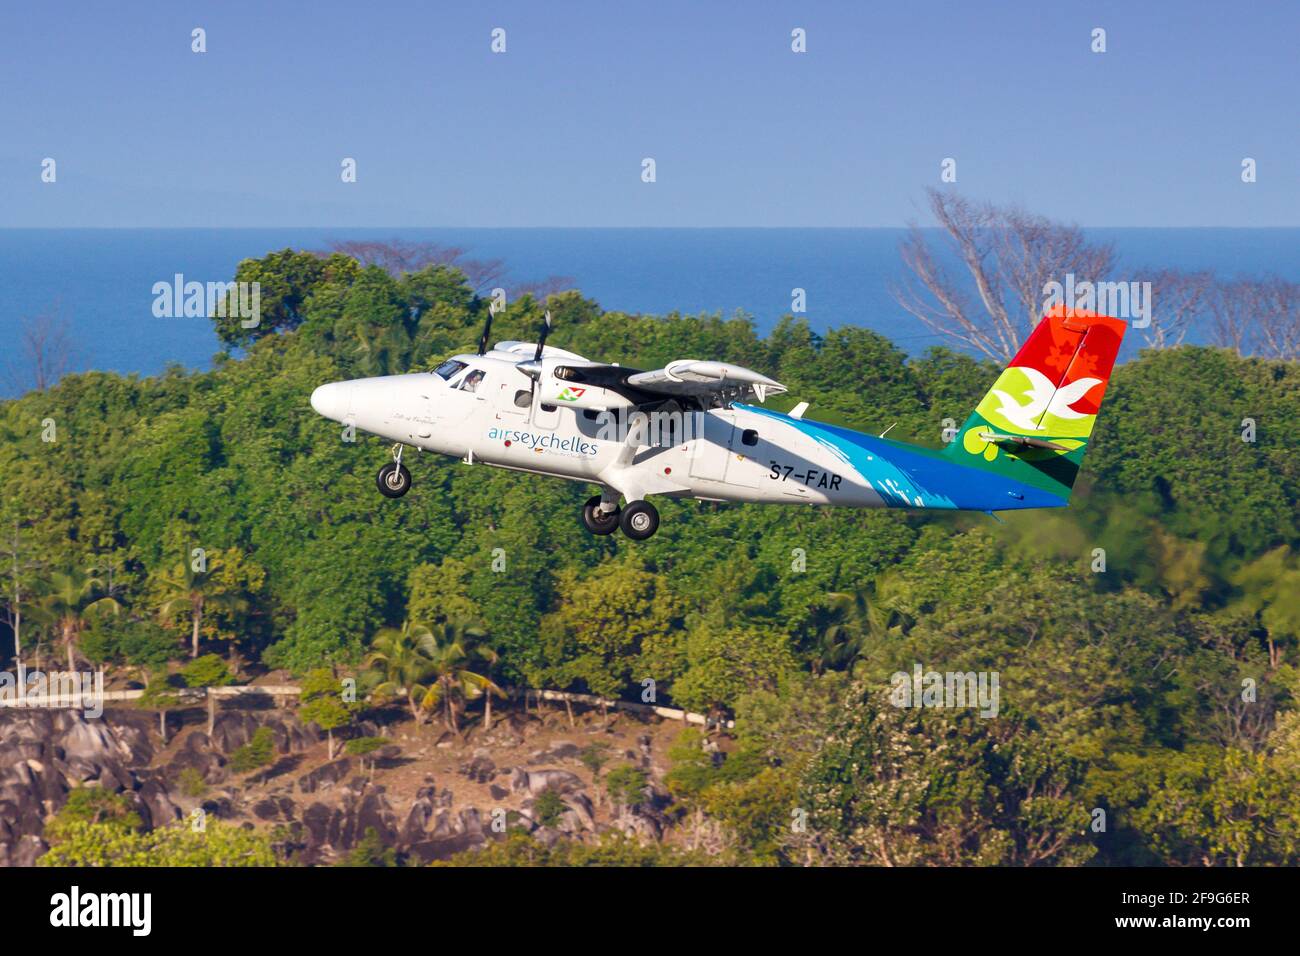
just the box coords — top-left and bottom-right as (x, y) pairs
(0, 709), (680, 866)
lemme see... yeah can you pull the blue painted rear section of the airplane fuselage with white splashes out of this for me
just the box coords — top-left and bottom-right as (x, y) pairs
(736, 405), (1067, 511)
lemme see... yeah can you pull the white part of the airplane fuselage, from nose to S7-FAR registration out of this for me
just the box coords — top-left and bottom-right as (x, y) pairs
(315, 356), (901, 507)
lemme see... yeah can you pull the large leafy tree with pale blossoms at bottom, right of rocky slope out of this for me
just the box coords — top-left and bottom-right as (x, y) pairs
(800, 683), (1096, 866)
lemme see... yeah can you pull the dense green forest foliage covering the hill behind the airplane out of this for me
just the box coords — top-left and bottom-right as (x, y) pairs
(0, 251), (1300, 865)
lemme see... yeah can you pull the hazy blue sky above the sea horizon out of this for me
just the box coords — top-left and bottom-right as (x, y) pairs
(0, 0), (1300, 226)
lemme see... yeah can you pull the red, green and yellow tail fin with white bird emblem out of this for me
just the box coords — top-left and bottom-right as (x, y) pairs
(945, 306), (1127, 503)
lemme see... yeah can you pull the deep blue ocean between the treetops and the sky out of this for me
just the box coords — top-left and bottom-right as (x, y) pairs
(0, 229), (1300, 397)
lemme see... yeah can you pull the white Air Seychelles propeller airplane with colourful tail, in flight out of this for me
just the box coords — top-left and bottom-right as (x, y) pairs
(311, 308), (1126, 540)
